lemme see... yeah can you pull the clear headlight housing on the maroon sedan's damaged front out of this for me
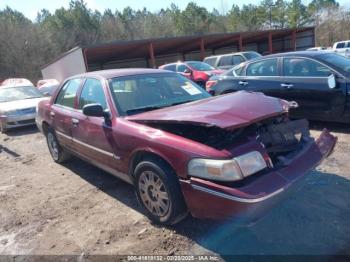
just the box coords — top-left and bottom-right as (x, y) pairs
(188, 151), (267, 181)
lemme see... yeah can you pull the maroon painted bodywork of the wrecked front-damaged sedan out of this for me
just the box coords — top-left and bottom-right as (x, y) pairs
(38, 69), (336, 219)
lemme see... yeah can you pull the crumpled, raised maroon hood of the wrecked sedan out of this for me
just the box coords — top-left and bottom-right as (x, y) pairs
(126, 91), (289, 129)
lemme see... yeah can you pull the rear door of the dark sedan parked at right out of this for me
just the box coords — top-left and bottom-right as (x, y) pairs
(236, 58), (282, 97)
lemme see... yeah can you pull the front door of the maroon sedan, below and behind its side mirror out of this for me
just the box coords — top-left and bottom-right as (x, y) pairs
(71, 78), (117, 169)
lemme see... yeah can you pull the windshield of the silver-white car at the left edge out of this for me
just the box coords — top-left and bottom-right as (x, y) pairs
(0, 86), (43, 103)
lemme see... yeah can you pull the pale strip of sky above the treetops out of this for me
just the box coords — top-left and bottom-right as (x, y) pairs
(0, 0), (349, 20)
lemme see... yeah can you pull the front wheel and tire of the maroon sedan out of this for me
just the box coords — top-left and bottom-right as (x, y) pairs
(134, 158), (187, 225)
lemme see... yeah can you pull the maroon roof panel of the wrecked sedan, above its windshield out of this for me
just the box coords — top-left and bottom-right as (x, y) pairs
(68, 68), (173, 79)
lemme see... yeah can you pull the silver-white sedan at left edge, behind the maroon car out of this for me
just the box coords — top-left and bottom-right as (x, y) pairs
(0, 86), (45, 133)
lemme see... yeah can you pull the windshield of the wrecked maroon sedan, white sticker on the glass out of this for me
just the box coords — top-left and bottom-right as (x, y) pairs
(109, 73), (211, 116)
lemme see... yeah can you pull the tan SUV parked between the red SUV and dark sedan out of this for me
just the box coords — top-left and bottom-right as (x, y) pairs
(203, 51), (261, 70)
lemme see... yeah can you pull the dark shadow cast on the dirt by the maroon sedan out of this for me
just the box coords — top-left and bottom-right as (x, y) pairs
(65, 159), (350, 255)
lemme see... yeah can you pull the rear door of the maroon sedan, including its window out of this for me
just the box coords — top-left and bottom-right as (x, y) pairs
(50, 78), (82, 151)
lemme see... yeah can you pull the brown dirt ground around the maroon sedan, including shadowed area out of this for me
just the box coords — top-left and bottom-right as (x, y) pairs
(0, 123), (350, 256)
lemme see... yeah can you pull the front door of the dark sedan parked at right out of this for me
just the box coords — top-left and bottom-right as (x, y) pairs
(281, 57), (346, 120)
